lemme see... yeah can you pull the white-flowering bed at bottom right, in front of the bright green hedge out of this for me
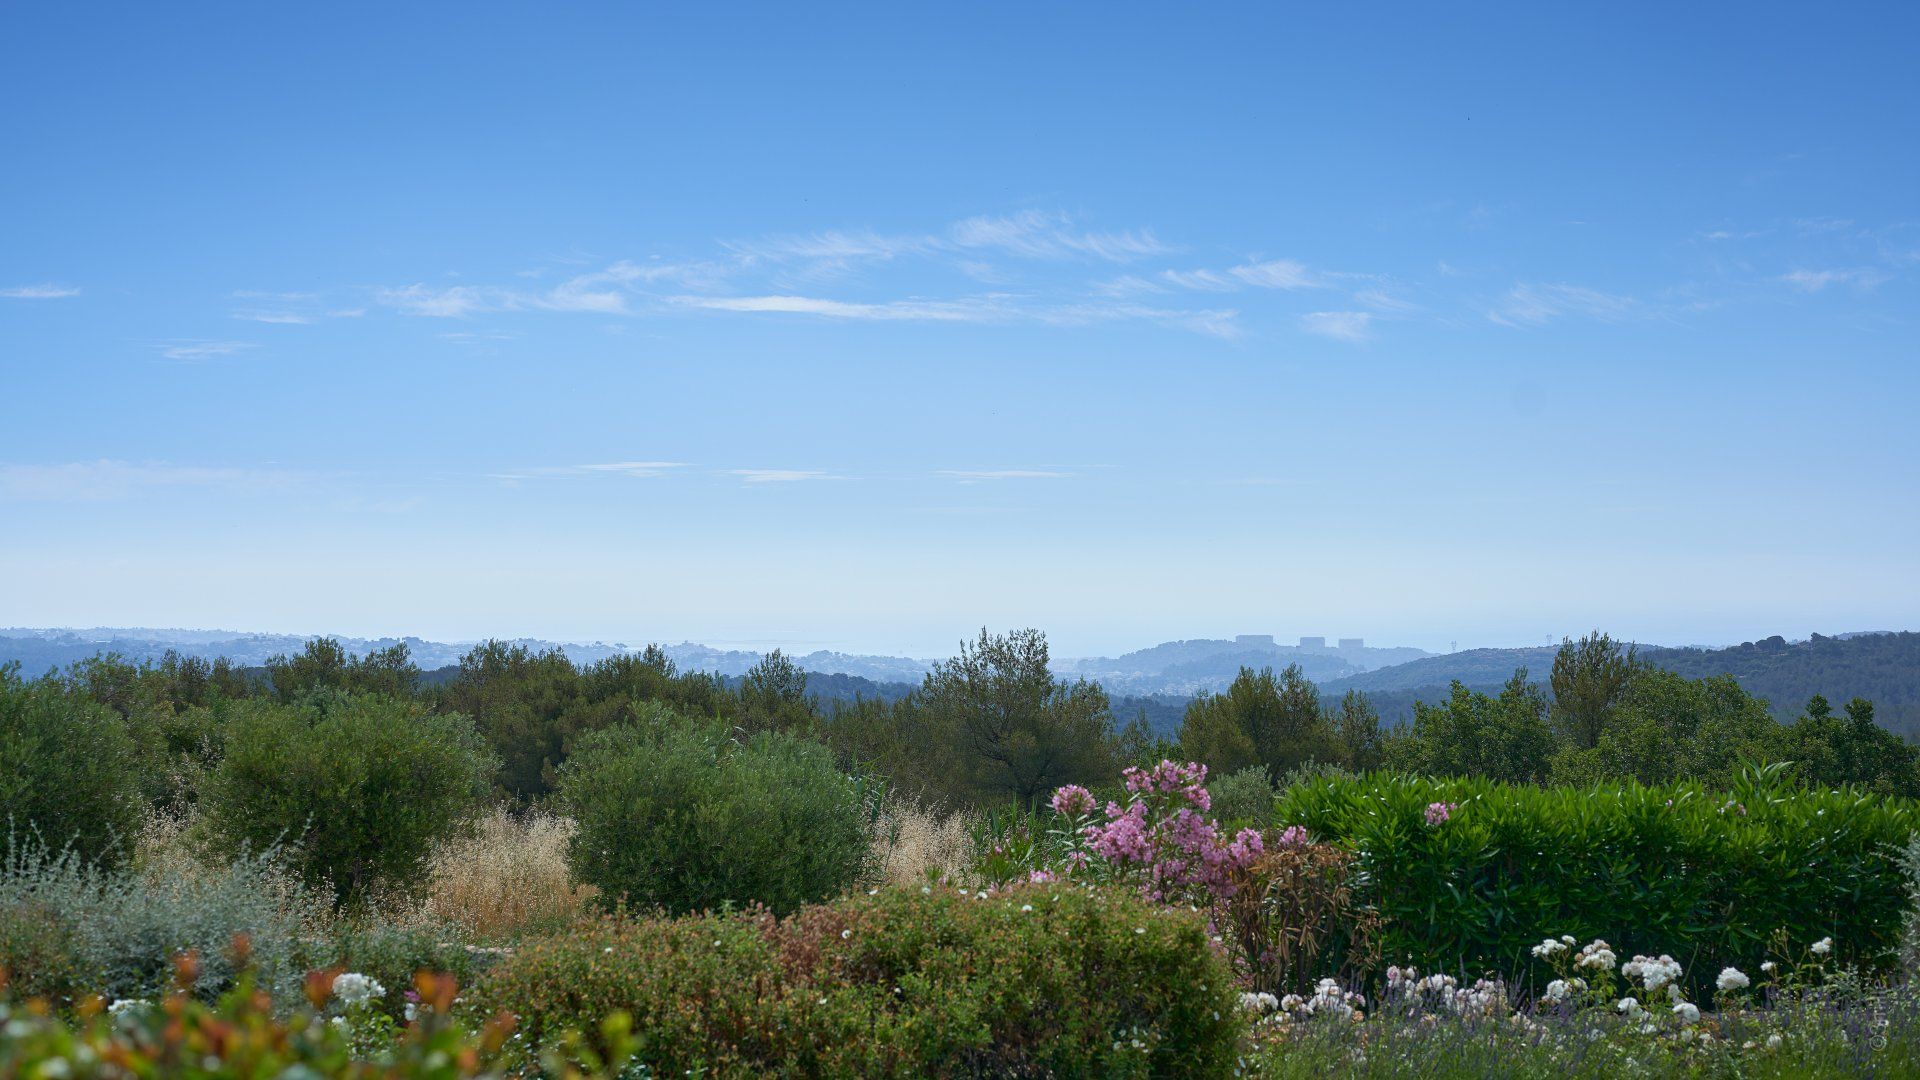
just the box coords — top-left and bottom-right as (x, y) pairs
(1242, 934), (1920, 1080)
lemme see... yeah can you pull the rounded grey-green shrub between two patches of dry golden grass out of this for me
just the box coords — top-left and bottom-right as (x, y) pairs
(561, 707), (874, 913)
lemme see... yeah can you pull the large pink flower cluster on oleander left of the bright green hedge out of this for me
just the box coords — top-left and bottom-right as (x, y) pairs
(1054, 761), (1263, 901)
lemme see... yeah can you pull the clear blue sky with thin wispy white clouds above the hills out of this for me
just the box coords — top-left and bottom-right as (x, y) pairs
(0, 4), (1920, 655)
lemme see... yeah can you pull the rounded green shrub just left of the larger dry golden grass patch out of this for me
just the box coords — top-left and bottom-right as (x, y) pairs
(202, 694), (495, 903)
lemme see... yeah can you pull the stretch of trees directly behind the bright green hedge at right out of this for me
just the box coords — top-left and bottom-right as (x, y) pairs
(1181, 632), (1920, 796)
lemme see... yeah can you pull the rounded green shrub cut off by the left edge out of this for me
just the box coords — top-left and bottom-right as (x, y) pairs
(0, 665), (144, 863)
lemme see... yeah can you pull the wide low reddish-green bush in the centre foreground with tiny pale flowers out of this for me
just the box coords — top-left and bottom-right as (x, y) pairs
(474, 886), (1242, 1076)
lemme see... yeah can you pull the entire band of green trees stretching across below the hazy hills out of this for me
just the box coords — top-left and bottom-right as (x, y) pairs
(0, 630), (1920, 876)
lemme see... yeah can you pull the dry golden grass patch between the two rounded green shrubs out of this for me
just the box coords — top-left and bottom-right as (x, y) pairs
(419, 807), (593, 940)
